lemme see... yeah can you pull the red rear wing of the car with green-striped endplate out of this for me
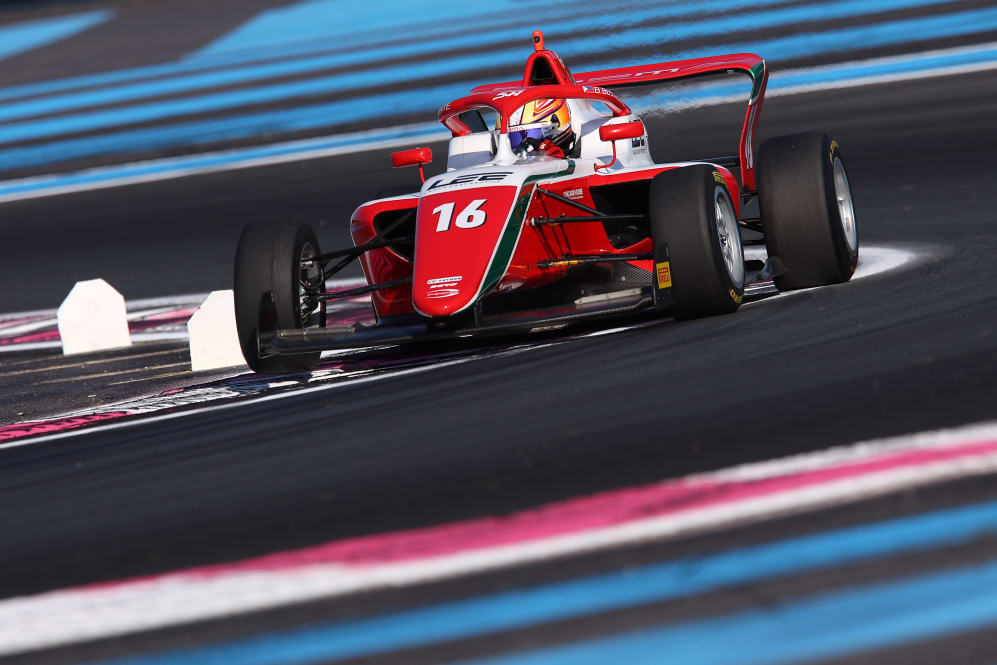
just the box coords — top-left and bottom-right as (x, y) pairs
(472, 53), (768, 190)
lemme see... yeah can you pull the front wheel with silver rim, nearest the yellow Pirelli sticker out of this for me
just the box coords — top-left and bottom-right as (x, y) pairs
(648, 164), (744, 319)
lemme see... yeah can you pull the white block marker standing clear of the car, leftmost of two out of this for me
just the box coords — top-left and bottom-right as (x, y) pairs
(56, 279), (132, 356)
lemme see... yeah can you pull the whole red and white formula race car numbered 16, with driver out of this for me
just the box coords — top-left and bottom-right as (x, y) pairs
(235, 32), (858, 373)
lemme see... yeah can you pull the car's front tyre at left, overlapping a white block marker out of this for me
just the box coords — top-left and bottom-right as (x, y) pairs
(234, 222), (325, 374)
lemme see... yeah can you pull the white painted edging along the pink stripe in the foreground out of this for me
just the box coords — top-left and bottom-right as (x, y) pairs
(0, 422), (997, 654)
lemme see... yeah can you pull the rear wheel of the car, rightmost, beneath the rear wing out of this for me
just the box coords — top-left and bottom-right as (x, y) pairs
(757, 132), (859, 290)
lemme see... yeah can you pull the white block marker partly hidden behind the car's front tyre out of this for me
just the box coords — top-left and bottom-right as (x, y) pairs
(187, 289), (246, 372)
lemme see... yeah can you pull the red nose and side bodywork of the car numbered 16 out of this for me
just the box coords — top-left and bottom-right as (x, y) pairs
(351, 166), (741, 317)
